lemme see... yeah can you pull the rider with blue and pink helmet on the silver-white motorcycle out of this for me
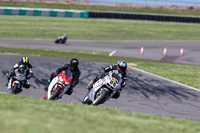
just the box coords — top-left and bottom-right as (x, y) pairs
(87, 60), (127, 99)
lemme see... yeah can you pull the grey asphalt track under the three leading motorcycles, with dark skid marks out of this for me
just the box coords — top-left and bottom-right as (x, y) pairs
(0, 53), (200, 121)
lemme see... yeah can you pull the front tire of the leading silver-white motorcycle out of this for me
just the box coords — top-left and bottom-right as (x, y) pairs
(92, 89), (109, 105)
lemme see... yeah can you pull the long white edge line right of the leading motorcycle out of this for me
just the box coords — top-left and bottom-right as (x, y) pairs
(128, 66), (200, 91)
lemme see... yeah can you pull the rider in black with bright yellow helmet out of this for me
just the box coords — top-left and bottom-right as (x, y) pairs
(6, 57), (33, 92)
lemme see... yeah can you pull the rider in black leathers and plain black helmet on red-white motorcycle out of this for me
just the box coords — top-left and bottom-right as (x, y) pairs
(44, 58), (81, 95)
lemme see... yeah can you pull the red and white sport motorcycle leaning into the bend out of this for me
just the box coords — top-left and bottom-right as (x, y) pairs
(45, 70), (72, 100)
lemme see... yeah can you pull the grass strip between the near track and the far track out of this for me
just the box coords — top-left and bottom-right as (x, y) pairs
(0, 47), (200, 89)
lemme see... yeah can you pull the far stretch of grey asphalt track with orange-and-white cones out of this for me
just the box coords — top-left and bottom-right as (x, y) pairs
(0, 38), (200, 66)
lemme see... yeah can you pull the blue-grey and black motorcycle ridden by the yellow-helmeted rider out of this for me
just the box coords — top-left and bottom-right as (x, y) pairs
(8, 67), (27, 94)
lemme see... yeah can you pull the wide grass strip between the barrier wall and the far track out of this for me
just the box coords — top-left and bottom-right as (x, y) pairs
(0, 15), (200, 41)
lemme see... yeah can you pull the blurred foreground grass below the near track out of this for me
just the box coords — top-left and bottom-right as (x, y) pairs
(0, 94), (200, 133)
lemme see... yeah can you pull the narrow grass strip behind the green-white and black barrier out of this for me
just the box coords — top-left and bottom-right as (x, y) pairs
(0, 1), (200, 16)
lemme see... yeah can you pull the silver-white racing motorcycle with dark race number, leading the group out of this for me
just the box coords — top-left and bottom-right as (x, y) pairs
(82, 71), (122, 105)
